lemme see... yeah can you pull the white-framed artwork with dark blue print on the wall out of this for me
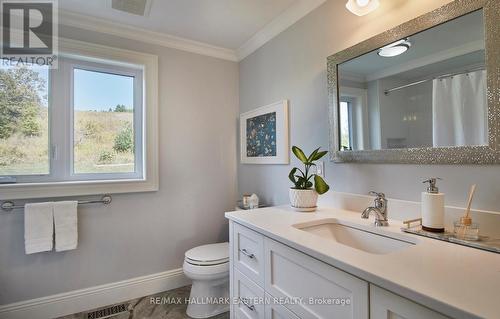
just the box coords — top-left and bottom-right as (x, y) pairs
(240, 100), (290, 164)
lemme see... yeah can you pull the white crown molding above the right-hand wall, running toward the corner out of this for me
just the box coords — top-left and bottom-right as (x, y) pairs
(236, 0), (326, 61)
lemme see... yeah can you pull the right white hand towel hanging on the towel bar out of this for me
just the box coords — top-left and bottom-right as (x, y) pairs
(54, 201), (78, 251)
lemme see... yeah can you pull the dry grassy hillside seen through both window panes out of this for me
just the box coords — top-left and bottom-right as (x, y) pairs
(0, 109), (134, 175)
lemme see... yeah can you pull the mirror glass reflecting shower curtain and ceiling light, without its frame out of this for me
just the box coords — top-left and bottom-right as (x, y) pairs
(338, 10), (488, 151)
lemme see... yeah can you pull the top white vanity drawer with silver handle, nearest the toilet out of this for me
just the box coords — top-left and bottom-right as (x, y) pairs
(233, 224), (264, 286)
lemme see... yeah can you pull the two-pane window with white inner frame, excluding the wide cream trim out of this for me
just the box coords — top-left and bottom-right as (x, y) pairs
(0, 58), (143, 182)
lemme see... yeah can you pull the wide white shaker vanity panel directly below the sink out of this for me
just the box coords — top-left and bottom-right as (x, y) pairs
(264, 238), (368, 319)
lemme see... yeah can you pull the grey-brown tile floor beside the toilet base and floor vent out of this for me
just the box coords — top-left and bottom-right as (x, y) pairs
(58, 286), (229, 319)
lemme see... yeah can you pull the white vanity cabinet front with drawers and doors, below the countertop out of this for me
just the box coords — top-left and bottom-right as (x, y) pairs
(230, 221), (454, 319)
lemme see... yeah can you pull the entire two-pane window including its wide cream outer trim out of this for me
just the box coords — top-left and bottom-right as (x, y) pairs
(0, 40), (158, 199)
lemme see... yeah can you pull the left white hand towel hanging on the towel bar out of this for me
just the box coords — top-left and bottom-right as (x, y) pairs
(24, 202), (54, 254)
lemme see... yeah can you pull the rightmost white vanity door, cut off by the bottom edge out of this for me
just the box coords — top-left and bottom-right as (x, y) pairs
(370, 285), (448, 319)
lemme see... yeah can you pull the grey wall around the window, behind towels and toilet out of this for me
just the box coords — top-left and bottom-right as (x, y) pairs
(0, 28), (238, 304)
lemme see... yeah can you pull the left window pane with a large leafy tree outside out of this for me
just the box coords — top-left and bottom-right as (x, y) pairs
(0, 66), (50, 180)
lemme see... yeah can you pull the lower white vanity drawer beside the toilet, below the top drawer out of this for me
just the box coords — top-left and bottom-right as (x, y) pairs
(233, 269), (265, 319)
